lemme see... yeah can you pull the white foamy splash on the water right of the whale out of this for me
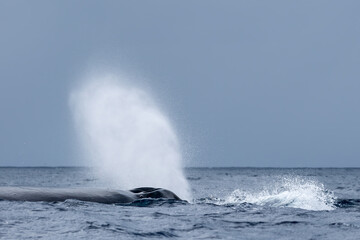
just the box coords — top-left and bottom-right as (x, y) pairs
(224, 177), (335, 211)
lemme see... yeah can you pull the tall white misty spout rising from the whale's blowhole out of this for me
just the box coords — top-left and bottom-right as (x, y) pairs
(70, 75), (190, 200)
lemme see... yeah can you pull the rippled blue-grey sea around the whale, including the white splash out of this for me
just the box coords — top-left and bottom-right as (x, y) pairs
(0, 168), (360, 240)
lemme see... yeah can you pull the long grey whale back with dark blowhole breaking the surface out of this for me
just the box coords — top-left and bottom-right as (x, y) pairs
(0, 187), (181, 204)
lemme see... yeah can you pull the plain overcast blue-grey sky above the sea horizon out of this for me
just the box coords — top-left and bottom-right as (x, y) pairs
(0, 0), (360, 167)
